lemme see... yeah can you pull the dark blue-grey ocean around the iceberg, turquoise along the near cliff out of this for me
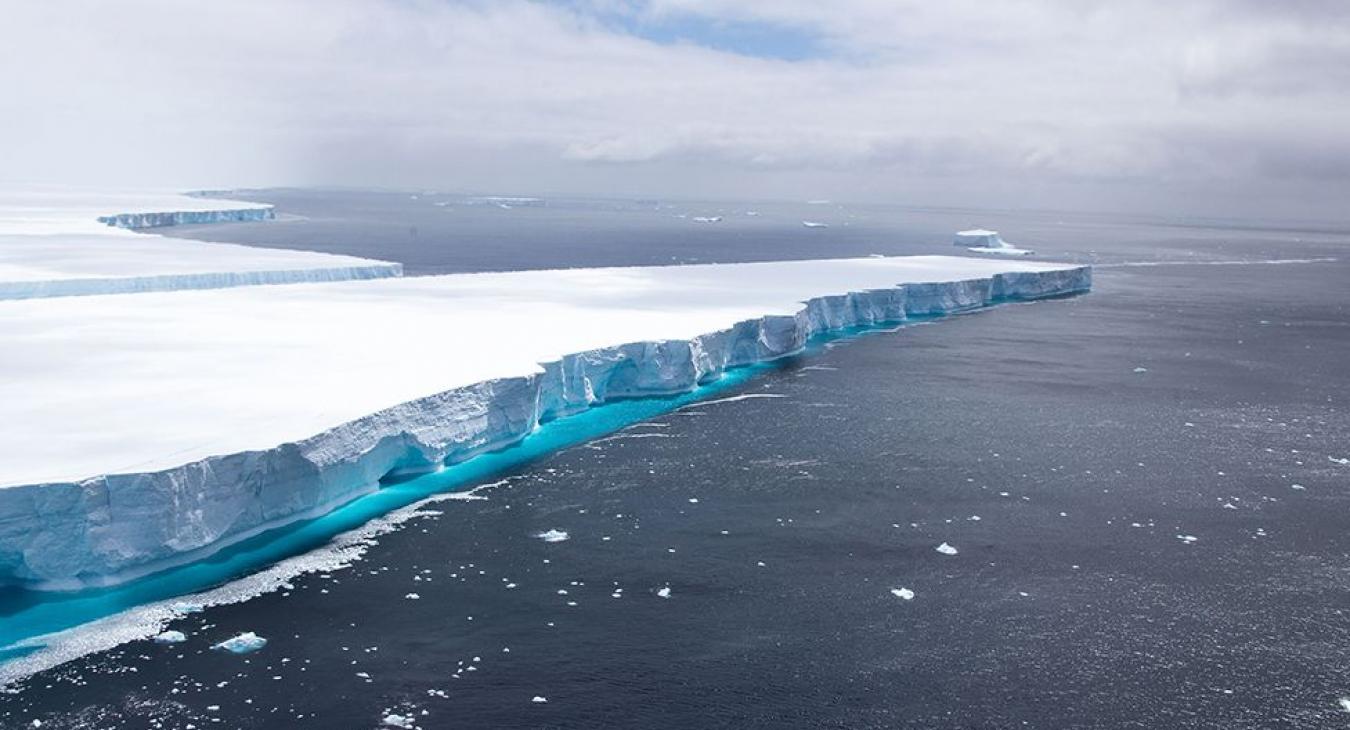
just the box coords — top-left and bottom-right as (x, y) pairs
(0, 190), (1350, 729)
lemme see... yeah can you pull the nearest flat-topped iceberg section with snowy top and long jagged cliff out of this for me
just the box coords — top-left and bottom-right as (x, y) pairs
(0, 256), (1091, 588)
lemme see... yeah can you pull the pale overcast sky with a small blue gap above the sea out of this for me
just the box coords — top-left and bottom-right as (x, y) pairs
(0, 0), (1350, 217)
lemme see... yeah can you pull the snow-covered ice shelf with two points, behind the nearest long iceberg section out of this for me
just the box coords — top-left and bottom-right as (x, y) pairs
(0, 188), (402, 300)
